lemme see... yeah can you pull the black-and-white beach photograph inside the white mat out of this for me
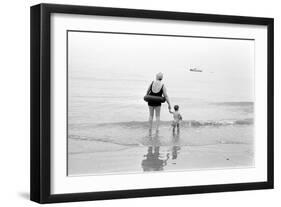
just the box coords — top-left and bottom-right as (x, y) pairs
(66, 30), (256, 176)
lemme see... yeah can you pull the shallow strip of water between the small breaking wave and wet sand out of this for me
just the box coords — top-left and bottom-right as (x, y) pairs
(69, 120), (253, 150)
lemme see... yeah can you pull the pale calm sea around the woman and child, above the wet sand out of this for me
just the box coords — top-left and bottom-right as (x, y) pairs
(68, 70), (254, 149)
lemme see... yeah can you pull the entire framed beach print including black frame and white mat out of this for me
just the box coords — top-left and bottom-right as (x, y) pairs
(31, 4), (273, 203)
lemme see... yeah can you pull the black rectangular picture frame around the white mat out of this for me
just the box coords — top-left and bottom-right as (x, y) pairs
(30, 4), (274, 203)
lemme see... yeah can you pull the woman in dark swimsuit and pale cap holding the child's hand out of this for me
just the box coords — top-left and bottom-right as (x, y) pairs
(147, 73), (171, 134)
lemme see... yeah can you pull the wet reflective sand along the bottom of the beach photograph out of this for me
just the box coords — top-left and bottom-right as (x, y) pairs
(68, 140), (254, 176)
